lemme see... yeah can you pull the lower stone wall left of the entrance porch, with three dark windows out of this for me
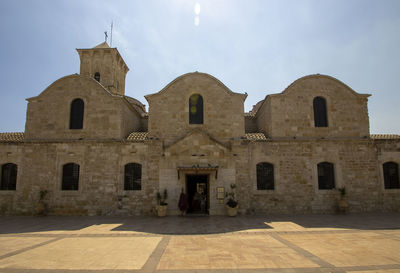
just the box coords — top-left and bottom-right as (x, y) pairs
(0, 142), (157, 215)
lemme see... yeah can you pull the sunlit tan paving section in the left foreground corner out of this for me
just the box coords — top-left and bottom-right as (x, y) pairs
(0, 237), (161, 270)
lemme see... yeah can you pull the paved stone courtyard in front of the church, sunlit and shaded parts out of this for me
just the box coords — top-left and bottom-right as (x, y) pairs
(0, 213), (400, 273)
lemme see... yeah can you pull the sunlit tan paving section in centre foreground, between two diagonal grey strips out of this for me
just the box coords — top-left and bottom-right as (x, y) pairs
(157, 235), (318, 269)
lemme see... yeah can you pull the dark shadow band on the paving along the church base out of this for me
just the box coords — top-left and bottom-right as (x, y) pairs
(0, 213), (400, 234)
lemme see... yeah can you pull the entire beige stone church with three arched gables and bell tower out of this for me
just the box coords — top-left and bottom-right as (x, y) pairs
(0, 42), (400, 215)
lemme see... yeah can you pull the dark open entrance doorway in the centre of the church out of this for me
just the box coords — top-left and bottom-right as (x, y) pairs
(186, 174), (210, 214)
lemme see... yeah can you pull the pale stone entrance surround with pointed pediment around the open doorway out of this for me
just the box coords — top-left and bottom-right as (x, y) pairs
(159, 131), (235, 215)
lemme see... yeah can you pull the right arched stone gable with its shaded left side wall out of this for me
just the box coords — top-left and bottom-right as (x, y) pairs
(256, 75), (369, 138)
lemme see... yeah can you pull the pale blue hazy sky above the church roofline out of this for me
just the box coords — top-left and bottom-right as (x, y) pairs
(0, 0), (400, 134)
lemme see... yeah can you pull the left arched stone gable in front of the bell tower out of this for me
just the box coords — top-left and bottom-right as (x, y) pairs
(25, 75), (132, 139)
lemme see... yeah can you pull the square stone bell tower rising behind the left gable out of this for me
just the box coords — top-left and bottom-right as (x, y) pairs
(76, 42), (129, 96)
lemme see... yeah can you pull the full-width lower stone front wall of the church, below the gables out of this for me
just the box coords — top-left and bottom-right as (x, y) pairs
(0, 138), (400, 215)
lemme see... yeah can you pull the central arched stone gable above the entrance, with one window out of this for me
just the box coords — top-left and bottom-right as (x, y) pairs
(146, 72), (247, 144)
